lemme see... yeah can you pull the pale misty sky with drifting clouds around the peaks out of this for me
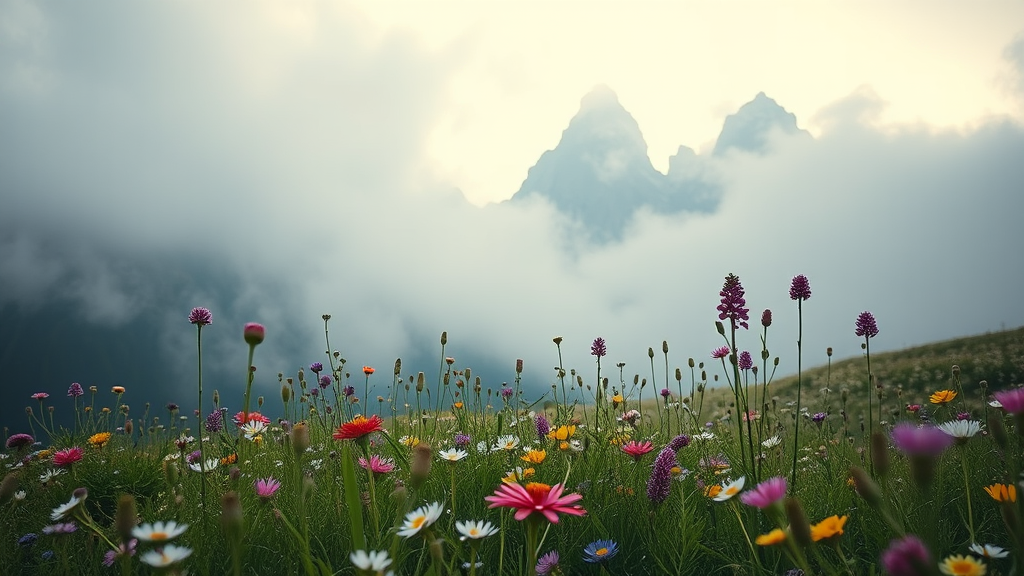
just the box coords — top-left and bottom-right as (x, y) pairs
(0, 0), (1024, 405)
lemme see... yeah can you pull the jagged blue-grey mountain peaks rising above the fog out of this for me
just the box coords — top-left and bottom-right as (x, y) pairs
(509, 86), (801, 243)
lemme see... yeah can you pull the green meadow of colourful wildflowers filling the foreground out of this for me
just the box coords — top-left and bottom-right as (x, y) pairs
(0, 275), (1024, 576)
